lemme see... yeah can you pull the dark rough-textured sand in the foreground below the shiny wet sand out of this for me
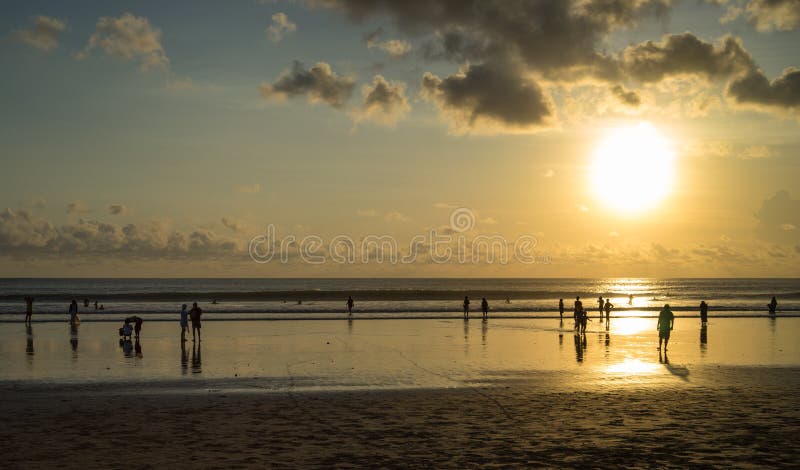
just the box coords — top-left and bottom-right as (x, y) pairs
(0, 367), (800, 468)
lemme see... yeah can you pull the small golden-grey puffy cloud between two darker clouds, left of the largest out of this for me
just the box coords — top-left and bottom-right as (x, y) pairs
(353, 75), (411, 126)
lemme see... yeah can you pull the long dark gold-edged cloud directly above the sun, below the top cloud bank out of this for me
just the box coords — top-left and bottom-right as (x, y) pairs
(621, 33), (754, 82)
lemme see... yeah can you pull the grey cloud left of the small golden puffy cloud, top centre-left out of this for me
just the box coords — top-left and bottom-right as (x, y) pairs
(261, 61), (355, 108)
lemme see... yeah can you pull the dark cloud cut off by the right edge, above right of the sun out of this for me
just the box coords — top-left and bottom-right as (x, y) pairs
(727, 68), (800, 111)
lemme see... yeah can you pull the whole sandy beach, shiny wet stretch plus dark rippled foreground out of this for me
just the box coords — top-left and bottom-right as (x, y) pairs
(0, 319), (800, 468)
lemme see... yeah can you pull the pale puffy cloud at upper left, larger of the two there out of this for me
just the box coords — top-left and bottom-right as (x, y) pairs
(78, 13), (169, 70)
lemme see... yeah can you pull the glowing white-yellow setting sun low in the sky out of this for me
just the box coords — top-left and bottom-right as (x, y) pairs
(591, 122), (675, 214)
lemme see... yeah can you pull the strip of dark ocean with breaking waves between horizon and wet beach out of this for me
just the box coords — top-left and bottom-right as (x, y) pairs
(0, 278), (800, 321)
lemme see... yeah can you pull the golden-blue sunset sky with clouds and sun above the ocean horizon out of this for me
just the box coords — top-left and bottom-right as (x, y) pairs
(0, 0), (800, 277)
